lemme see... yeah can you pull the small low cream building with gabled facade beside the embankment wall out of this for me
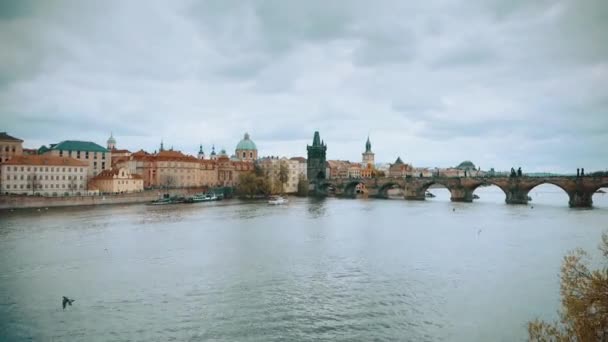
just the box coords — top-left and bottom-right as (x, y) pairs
(89, 167), (144, 193)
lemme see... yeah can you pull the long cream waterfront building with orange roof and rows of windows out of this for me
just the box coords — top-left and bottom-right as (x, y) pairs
(0, 155), (89, 196)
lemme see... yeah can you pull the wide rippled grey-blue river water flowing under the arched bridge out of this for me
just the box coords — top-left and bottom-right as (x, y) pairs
(0, 188), (608, 341)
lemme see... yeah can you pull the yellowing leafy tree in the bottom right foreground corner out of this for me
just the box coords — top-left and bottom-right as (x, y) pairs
(528, 233), (608, 342)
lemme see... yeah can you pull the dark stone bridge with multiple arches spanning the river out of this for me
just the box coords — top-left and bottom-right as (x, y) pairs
(311, 176), (608, 208)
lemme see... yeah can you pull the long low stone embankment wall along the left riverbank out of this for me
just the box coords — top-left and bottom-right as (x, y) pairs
(0, 188), (203, 210)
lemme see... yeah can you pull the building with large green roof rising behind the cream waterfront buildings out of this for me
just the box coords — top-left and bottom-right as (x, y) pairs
(41, 140), (112, 178)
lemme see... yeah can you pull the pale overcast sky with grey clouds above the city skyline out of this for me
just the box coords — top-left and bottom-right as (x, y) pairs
(0, 0), (608, 172)
